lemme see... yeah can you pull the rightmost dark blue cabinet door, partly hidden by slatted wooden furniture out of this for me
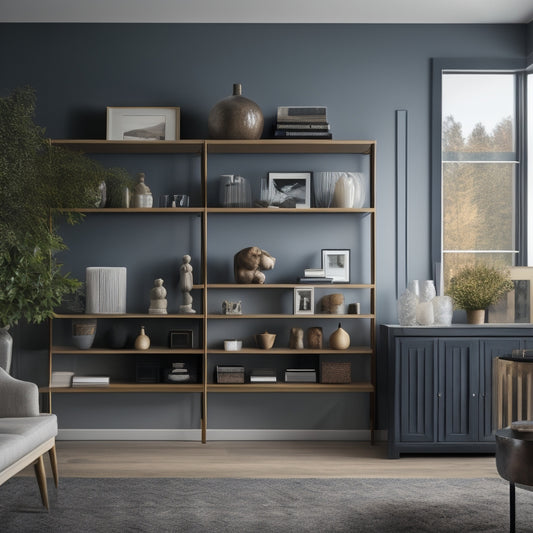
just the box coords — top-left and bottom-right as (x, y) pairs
(479, 339), (522, 441)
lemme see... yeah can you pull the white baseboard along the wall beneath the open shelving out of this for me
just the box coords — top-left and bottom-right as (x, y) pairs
(57, 429), (387, 441)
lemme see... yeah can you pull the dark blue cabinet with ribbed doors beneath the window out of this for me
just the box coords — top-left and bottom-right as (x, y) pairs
(381, 324), (533, 458)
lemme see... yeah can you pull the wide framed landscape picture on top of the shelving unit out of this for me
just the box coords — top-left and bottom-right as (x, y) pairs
(107, 107), (180, 141)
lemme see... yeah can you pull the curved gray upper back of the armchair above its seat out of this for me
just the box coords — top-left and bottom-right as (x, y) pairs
(0, 368), (39, 417)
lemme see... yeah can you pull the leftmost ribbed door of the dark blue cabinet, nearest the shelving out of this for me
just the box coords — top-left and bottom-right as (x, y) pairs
(395, 338), (435, 442)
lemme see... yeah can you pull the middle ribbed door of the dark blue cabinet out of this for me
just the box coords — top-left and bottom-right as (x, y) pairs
(438, 339), (479, 442)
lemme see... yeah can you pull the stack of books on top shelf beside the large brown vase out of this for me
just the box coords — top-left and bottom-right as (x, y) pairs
(274, 106), (333, 139)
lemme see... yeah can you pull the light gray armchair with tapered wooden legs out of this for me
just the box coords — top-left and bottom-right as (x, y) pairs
(0, 368), (59, 509)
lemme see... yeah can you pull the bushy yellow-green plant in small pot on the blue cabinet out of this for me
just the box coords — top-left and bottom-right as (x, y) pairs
(447, 265), (514, 324)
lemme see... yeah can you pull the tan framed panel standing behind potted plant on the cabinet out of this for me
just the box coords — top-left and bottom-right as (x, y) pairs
(487, 267), (533, 324)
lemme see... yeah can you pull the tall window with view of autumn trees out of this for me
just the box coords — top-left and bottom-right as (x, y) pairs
(432, 60), (533, 291)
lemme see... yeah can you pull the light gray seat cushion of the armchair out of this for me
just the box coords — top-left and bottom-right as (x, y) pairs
(0, 415), (57, 471)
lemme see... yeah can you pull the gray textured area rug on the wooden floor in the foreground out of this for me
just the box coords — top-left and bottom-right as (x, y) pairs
(0, 477), (533, 533)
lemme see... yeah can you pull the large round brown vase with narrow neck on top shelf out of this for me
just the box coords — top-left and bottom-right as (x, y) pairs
(207, 83), (264, 139)
